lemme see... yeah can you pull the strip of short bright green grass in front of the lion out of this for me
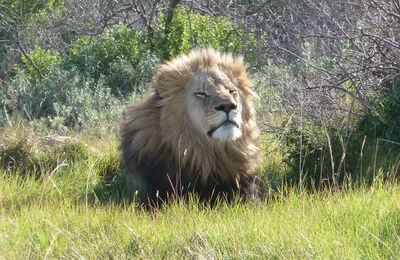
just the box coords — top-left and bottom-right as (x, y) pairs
(0, 177), (400, 258)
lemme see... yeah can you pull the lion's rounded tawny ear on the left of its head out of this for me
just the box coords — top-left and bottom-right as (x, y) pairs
(153, 62), (191, 97)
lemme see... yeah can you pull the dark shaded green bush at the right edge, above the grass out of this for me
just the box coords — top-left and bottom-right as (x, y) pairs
(282, 76), (400, 187)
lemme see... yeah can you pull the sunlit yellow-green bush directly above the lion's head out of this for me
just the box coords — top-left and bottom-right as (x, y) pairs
(156, 8), (245, 59)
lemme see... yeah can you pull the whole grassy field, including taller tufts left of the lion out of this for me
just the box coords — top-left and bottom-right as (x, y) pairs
(0, 130), (400, 259)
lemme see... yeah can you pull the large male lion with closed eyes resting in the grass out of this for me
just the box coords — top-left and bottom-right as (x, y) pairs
(120, 48), (264, 203)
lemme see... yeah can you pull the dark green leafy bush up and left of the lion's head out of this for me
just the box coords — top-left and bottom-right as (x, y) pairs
(65, 24), (159, 96)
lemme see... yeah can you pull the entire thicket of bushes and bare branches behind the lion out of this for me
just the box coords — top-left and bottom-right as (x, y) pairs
(0, 0), (400, 187)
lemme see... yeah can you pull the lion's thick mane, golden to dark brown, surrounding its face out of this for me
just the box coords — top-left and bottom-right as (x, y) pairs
(120, 49), (263, 204)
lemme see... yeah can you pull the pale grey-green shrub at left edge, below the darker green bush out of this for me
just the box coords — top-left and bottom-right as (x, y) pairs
(0, 66), (125, 128)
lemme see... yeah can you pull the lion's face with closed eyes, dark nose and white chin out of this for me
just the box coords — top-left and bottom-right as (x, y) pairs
(186, 71), (243, 141)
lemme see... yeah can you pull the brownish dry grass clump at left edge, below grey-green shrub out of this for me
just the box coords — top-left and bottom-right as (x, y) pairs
(0, 125), (93, 177)
